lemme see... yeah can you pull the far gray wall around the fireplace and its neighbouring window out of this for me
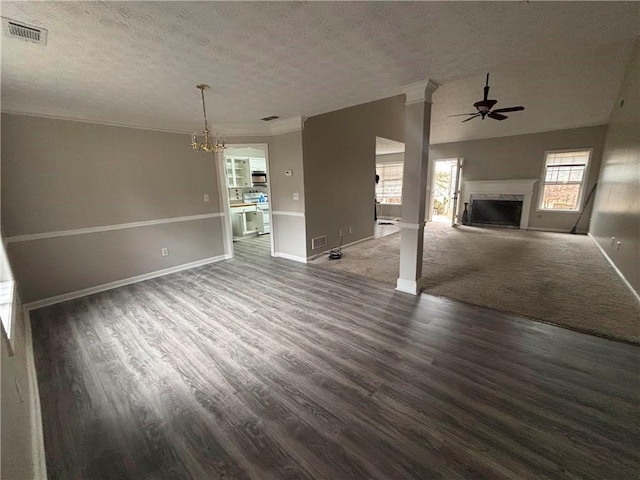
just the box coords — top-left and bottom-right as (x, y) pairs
(429, 125), (606, 232)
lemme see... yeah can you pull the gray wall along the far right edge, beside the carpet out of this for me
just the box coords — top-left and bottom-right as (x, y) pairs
(590, 41), (640, 293)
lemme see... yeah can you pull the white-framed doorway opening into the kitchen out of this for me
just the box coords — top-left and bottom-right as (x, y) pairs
(222, 144), (274, 259)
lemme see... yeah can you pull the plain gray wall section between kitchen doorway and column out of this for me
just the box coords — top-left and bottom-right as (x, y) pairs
(303, 95), (405, 256)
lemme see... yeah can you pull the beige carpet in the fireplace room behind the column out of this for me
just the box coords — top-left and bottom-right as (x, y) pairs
(311, 223), (640, 343)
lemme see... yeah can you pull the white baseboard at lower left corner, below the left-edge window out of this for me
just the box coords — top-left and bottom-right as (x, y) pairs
(22, 312), (47, 480)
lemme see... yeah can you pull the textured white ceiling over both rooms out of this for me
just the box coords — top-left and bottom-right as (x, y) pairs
(0, 1), (640, 143)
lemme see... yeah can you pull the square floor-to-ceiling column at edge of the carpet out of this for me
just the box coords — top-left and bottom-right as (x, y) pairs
(396, 80), (438, 295)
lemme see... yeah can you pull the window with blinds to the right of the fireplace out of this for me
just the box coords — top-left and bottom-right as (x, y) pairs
(539, 150), (591, 212)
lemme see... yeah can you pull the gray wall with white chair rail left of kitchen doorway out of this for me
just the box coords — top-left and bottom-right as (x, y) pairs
(2, 114), (224, 303)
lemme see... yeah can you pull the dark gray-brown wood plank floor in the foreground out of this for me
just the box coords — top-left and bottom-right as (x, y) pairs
(31, 236), (640, 480)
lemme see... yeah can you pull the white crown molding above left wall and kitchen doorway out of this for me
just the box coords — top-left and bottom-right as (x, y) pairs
(2, 109), (306, 139)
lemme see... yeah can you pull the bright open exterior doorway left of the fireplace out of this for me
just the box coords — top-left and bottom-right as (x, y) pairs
(431, 158), (459, 223)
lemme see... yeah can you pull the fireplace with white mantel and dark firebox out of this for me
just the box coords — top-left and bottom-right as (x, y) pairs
(458, 178), (539, 230)
